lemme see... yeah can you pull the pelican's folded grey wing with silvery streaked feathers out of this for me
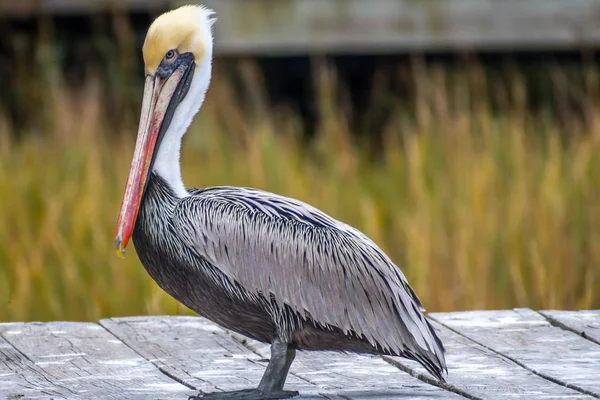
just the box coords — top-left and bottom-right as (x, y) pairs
(173, 187), (445, 376)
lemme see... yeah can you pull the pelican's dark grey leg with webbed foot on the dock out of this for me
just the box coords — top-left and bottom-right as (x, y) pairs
(188, 339), (298, 400)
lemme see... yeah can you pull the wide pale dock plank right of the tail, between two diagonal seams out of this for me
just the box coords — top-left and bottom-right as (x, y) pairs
(430, 309), (600, 398)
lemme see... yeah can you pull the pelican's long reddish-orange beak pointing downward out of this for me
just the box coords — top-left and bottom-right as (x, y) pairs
(115, 64), (189, 257)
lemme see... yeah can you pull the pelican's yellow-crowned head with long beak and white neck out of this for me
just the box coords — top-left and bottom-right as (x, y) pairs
(115, 5), (215, 256)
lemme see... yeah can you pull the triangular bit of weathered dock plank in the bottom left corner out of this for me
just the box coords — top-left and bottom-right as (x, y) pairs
(0, 336), (76, 400)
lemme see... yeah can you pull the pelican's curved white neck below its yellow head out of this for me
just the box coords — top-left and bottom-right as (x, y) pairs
(153, 56), (212, 197)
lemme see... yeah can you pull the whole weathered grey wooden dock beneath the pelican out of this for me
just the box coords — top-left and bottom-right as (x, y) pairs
(0, 309), (600, 400)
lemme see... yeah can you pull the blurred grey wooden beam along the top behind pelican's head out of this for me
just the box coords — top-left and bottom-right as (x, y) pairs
(0, 0), (600, 54)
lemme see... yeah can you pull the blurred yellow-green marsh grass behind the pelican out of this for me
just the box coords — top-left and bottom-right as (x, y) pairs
(0, 54), (600, 321)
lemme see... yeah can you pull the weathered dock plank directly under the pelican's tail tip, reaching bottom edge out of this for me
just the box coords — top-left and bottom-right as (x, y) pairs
(384, 321), (592, 400)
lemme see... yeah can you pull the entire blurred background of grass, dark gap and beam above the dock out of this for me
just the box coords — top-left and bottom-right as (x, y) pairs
(0, 0), (600, 321)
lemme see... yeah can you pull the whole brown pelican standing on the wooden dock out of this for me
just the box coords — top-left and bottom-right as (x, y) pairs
(115, 6), (447, 399)
